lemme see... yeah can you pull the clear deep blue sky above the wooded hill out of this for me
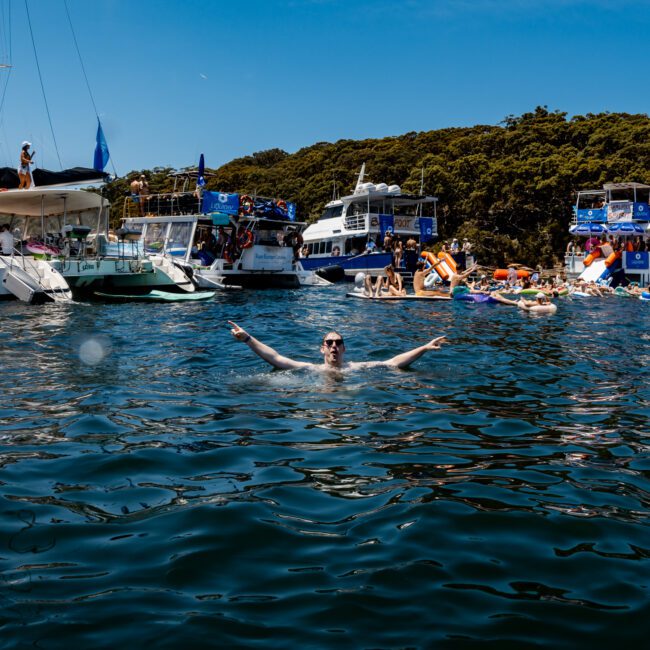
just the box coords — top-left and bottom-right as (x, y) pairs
(0, 0), (650, 175)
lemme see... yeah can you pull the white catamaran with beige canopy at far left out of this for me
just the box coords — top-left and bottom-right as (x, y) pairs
(0, 180), (195, 302)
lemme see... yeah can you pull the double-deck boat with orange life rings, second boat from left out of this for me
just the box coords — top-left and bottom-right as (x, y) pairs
(123, 184), (311, 289)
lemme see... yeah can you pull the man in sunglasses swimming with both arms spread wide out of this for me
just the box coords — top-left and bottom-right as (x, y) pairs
(228, 320), (446, 370)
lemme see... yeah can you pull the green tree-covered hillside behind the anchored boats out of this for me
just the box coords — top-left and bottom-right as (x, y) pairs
(105, 107), (650, 266)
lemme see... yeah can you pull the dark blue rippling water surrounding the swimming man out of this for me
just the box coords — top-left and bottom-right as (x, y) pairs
(0, 287), (650, 648)
